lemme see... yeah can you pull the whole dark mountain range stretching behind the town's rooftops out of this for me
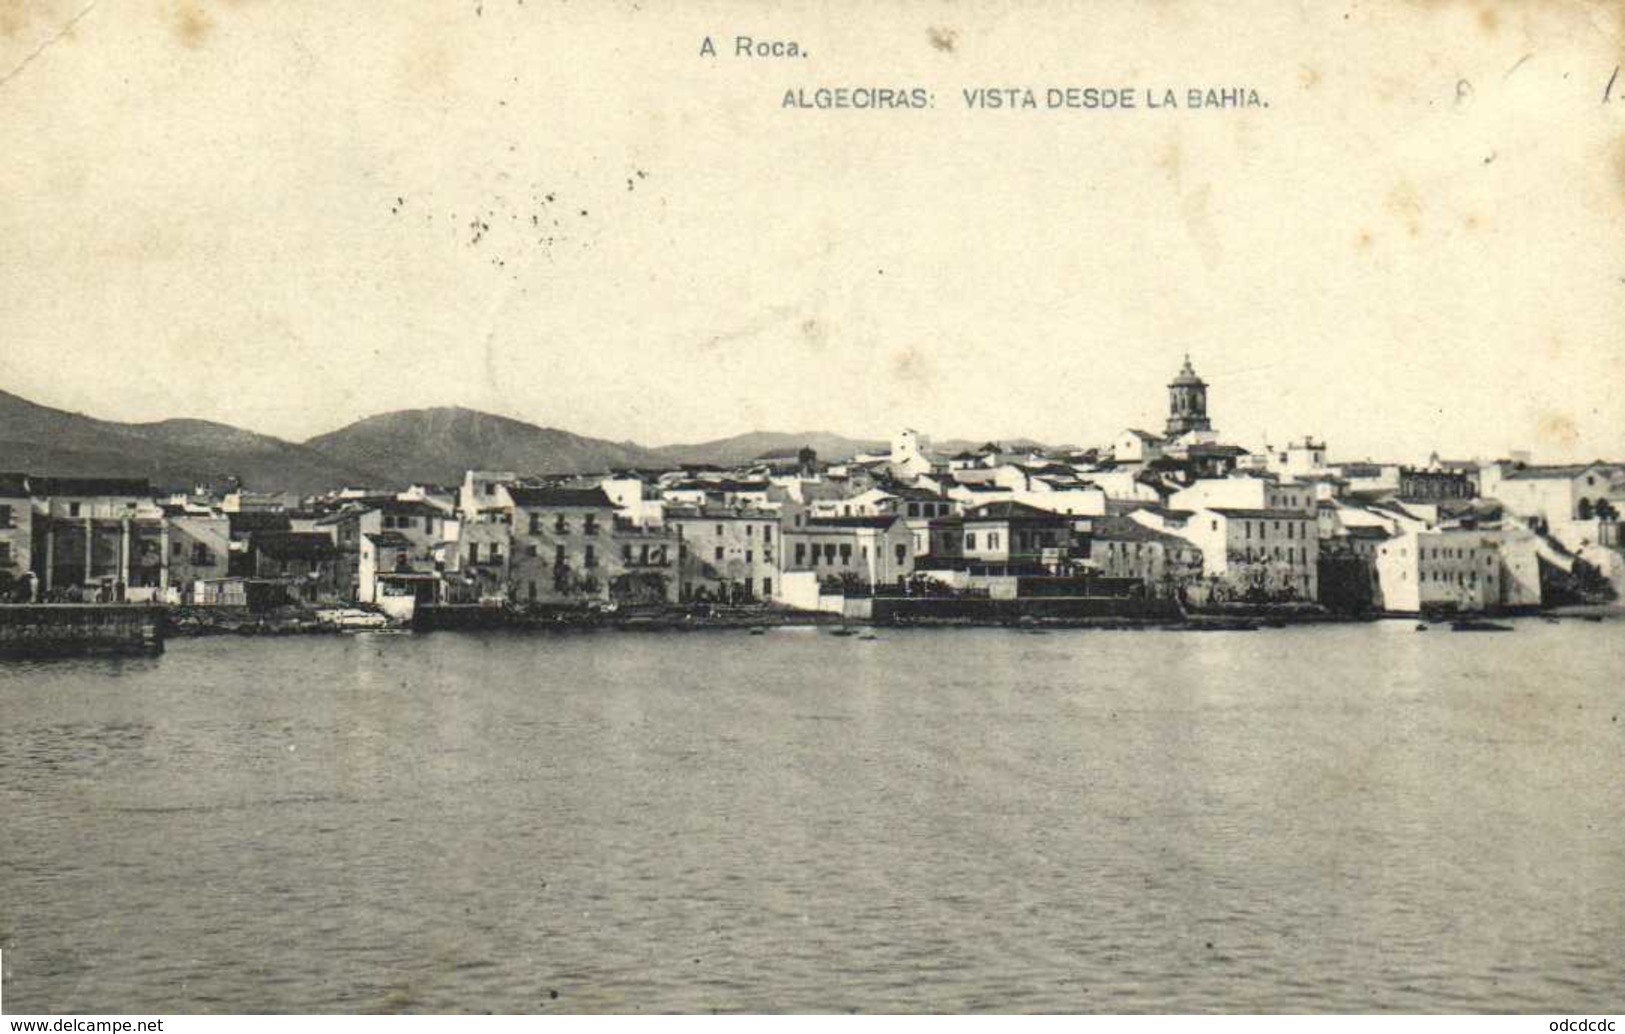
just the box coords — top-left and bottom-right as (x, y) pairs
(0, 392), (1053, 494)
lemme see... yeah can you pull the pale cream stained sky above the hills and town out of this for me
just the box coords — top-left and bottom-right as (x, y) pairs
(0, 0), (1625, 460)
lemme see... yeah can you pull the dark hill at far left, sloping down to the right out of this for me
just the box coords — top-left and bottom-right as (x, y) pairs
(0, 392), (375, 493)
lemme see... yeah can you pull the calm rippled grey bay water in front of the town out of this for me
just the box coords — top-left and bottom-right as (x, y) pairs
(0, 621), (1625, 1013)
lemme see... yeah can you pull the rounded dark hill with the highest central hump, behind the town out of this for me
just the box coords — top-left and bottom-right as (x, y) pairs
(306, 406), (673, 484)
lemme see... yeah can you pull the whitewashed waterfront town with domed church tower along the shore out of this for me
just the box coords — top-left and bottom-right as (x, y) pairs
(0, 356), (1625, 637)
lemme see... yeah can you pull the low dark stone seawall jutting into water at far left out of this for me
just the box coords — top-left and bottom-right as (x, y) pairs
(0, 603), (164, 657)
